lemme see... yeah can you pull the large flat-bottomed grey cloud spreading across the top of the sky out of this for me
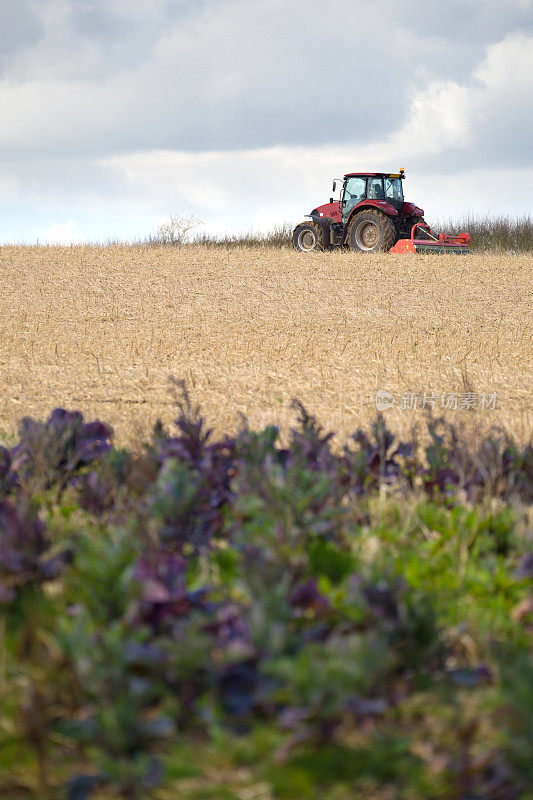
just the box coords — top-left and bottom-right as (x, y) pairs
(0, 0), (526, 161)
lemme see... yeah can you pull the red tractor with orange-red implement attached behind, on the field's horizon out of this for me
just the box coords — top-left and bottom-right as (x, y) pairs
(292, 169), (470, 253)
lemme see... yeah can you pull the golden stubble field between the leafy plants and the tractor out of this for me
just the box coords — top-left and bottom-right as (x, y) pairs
(0, 246), (533, 444)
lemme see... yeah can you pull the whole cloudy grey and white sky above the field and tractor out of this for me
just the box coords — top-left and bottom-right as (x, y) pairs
(0, 0), (533, 242)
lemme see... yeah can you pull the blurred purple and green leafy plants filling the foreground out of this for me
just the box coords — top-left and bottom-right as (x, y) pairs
(0, 396), (533, 800)
